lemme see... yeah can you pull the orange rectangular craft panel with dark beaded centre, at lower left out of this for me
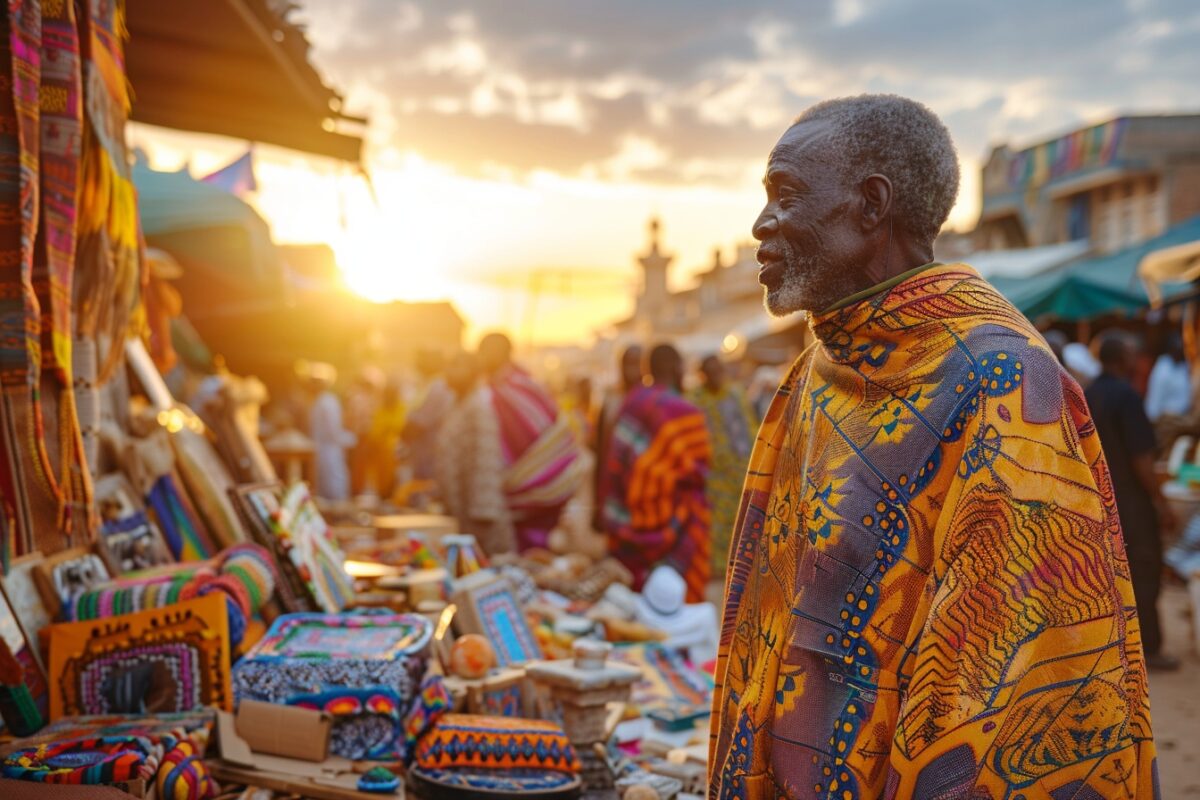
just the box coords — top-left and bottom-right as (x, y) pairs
(50, 594), (232, 720)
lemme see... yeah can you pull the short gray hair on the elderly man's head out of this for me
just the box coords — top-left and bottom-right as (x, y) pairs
(793, 95), (959, 245)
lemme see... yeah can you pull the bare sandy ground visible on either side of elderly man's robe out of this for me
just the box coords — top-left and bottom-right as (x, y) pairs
(708, 583), (1200, 800)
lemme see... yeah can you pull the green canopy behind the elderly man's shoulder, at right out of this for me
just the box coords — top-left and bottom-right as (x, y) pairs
(992, 217), (1200, 321)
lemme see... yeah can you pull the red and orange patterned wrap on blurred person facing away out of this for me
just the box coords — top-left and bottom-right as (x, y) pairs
(599, 386), (713, 602)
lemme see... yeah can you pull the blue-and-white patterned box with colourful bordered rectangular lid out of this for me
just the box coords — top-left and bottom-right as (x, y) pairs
(233, 614), (433, 708)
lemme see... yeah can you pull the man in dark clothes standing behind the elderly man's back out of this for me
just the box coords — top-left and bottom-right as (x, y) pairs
(1086, 332), (1180, 669)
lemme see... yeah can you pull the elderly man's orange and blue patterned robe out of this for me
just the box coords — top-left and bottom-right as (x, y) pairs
(709, 264), (1158, 800)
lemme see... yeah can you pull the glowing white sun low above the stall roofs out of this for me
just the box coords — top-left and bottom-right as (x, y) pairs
(334, 229), (452, 302)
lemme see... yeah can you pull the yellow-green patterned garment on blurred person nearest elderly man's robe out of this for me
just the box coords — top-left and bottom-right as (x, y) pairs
(688, 385), (758, 575)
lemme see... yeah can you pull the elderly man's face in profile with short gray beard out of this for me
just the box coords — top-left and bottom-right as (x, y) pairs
(754, 122), (864, 317)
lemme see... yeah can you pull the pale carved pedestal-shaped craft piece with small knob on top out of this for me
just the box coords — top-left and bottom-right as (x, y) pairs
(527, 639), (642, 790)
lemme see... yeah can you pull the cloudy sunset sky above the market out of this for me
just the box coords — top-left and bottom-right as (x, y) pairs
(133, 0), (1200, 342)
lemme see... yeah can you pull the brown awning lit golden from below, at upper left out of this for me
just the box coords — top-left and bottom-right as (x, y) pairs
(126, 0), (365, 163)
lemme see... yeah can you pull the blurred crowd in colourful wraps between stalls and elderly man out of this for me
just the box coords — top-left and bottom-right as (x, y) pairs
(258, 333), (778, 601)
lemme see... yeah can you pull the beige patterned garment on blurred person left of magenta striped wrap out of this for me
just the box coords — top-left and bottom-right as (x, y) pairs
(437, 386), (516, 555)
